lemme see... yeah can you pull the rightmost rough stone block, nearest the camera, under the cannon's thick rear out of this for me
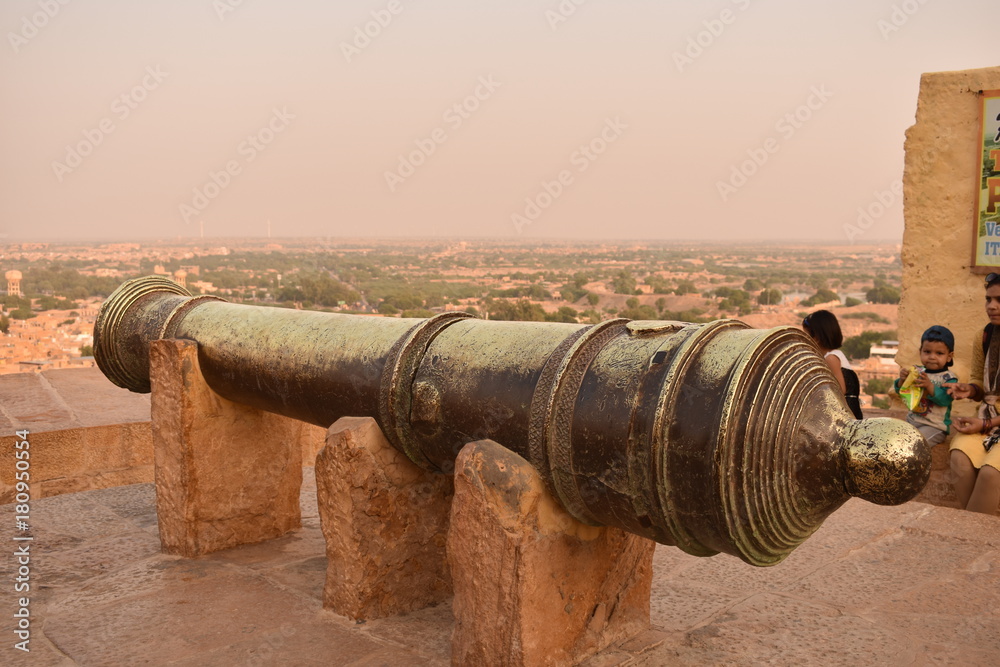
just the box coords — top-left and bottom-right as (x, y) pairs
(448, 441), (655, 665)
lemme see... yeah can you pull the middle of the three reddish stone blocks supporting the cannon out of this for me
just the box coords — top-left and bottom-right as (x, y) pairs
(316, 417), (452, 620)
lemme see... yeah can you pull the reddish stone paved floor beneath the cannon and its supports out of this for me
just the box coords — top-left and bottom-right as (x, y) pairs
(0, 469), (1000, 667)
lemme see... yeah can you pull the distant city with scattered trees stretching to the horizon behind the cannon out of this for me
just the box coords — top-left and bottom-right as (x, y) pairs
(0, 238), (901, 407)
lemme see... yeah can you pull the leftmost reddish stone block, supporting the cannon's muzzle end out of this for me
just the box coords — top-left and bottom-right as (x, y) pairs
(149, 340), (304, 558)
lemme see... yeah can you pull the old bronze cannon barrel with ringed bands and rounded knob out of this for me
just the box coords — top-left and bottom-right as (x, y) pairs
(94, 276), (930, 565)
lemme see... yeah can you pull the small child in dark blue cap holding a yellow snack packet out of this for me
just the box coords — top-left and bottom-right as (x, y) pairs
(895, 324), (958, 447)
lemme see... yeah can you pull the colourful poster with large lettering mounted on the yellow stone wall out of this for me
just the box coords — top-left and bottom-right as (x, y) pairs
(972, 90), (1000, 273)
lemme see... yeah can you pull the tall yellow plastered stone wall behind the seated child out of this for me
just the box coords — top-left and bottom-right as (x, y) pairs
(900, 67), (1000, 388)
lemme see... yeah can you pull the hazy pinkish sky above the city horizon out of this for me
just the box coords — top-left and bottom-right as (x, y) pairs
(0, 0), (1000, 242)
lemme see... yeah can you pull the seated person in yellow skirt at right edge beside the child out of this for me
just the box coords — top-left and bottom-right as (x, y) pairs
(949, 273), (1000, 514)
